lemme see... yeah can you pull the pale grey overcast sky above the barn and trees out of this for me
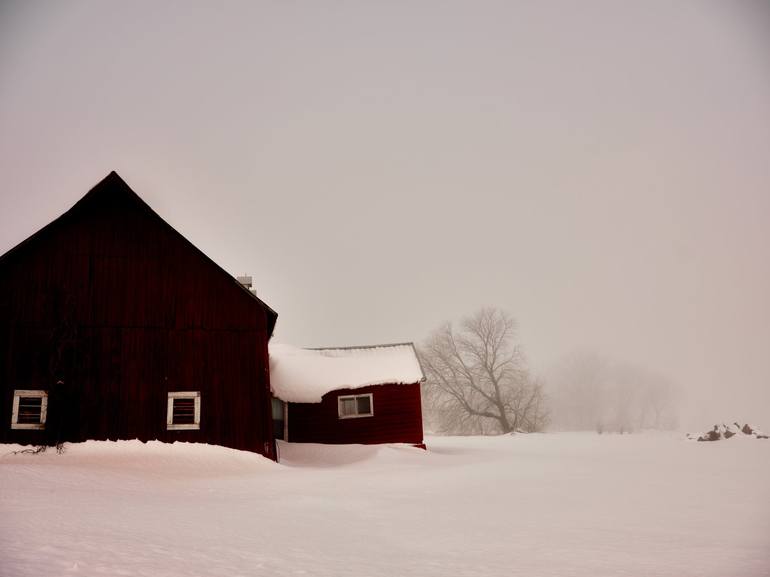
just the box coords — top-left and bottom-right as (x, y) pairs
(0, 0), (770, 428)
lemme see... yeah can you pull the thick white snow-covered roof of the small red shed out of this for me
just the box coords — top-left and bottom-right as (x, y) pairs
(270, 343), (425, 403)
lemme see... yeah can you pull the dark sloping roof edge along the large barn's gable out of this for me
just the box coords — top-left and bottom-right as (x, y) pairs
(0, 170), (278, 335)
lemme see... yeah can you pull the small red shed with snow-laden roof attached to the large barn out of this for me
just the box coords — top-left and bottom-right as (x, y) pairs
(270, 343), (425, 447)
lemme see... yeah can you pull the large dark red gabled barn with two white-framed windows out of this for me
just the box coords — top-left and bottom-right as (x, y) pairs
(0, 172), (277, 458)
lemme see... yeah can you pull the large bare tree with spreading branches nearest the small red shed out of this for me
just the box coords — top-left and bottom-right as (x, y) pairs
(419, 308), (548, 434)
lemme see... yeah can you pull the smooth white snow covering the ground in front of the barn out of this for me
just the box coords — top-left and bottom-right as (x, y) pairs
(0, 434), (770, 577)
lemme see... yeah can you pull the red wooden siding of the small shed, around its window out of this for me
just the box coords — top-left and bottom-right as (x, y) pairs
(289, 383), (422, 445)
